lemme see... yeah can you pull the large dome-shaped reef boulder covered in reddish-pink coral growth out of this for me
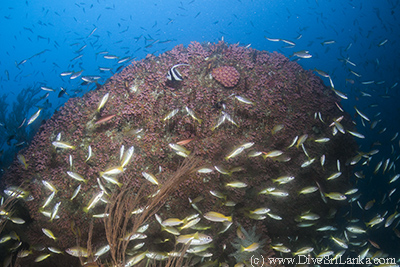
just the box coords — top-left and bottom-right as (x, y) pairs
(2, 42), (357, 266)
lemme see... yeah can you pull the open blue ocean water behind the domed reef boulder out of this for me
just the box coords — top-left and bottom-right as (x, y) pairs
(0, 0), (400, 264)
